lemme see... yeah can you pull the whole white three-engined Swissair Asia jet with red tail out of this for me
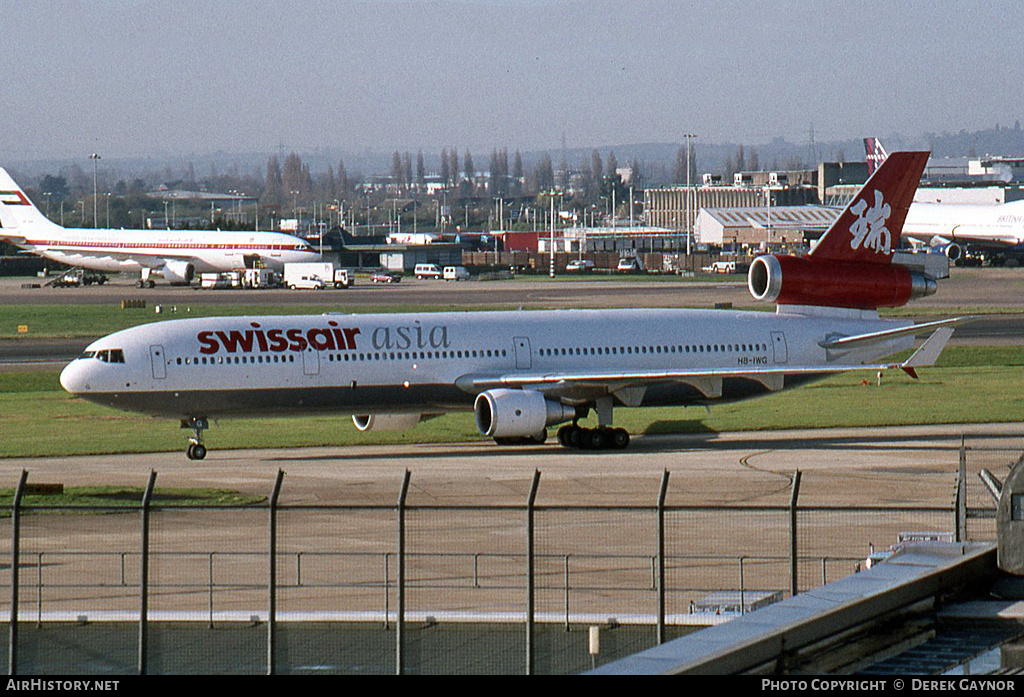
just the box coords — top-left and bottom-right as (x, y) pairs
(60, 153), (955, 460)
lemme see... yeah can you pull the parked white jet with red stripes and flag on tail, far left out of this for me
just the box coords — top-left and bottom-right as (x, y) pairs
(0, 169), (321, 288)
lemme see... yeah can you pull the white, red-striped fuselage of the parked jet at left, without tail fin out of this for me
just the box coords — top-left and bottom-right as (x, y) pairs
(19, 226), (319, 273)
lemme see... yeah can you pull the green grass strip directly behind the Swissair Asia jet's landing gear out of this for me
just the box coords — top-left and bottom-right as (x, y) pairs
(0, 346), (1024, 458)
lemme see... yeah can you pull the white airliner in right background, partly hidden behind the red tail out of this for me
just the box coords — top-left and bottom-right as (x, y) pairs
(864, 138), (1024, 261)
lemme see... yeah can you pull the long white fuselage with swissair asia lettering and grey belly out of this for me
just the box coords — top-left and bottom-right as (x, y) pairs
(60, 309), (912, 418)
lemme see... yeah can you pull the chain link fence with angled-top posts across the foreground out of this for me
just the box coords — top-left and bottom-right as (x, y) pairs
(0, 440), (1007, 674)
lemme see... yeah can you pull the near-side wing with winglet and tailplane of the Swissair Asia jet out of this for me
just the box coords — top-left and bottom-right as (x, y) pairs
(456, 320), (952, 405)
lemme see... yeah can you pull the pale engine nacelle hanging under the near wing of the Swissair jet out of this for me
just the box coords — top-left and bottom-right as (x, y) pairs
(473, 390), (575, 438)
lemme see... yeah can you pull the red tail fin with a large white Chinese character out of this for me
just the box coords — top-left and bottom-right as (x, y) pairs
(808, 151), (930, 264)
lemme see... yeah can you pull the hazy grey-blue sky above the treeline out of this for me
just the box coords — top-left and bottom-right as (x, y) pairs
(0, 0), (1024, 161)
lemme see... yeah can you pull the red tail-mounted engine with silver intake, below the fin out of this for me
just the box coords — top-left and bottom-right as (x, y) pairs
(746, 254), (936, 310)
